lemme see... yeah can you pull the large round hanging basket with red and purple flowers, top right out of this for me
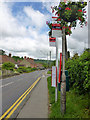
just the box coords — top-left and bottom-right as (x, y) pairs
(52, 2), (87, 27)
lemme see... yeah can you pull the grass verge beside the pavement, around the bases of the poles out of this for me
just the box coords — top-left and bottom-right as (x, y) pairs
(47, 77), (90, 119)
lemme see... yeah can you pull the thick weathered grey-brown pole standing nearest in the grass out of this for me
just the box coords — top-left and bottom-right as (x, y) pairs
(61, 28), (66, 114)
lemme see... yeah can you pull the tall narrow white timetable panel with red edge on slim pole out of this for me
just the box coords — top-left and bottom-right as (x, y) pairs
(51, 66), (57, 87)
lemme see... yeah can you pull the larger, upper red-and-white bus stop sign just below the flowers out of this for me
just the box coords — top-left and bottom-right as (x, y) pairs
(52, 23), (62, 37)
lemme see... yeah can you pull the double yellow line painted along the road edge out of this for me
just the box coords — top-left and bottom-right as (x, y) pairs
(0, 77), (41, 120)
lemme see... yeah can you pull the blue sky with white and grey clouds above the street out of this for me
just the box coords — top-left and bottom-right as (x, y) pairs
(0, 0), (89, 59)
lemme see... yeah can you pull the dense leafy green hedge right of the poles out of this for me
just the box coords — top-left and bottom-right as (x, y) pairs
(66, 50), (90, 94)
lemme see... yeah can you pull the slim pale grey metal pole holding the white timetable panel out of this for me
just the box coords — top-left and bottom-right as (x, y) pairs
(55, 38), (58, 102)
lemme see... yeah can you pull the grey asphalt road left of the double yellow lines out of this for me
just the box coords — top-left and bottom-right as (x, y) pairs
(0, 70), (45, 116)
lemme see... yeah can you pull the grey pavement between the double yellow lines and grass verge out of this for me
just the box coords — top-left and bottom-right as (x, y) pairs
(17, 70), (48, 118)
